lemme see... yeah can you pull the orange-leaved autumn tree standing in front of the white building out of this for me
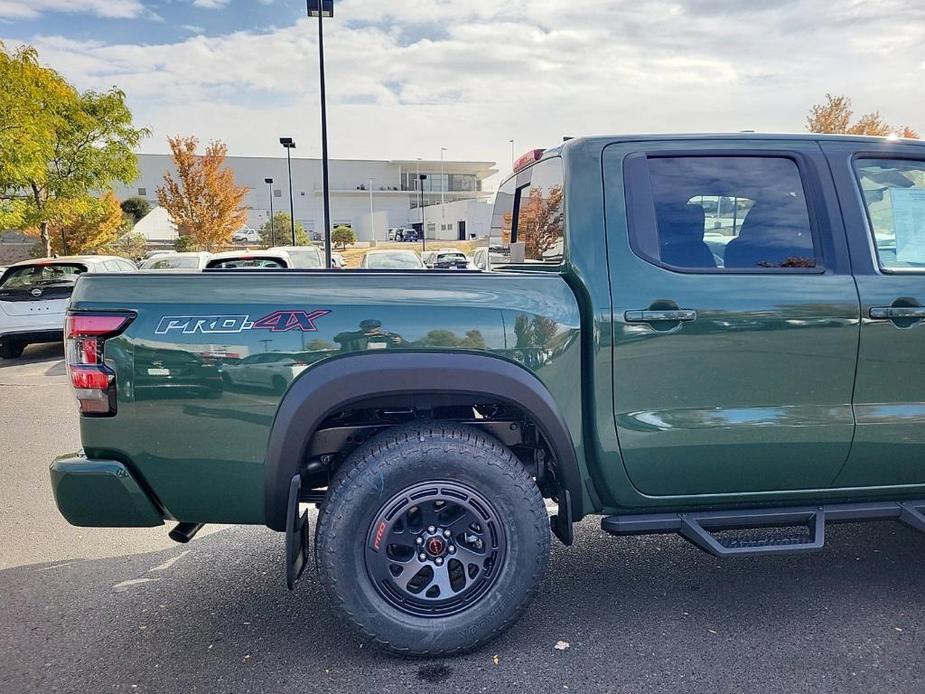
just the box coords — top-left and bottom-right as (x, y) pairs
(157, 135), (248, 251)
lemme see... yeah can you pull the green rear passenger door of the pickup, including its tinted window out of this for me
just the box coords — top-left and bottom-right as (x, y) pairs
(604, 140), (859, 495)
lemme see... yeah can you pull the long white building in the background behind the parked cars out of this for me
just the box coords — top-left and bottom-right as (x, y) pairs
(115, 154), (497, 241)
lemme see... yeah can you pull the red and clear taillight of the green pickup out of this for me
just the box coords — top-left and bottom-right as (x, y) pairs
(64, 313), (132, 417)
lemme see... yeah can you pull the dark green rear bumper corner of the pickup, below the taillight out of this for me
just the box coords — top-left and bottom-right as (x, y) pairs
(50, 453), (164, 528)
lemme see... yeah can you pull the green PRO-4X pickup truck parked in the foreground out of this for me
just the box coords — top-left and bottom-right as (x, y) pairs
(51, 134), (925, 655)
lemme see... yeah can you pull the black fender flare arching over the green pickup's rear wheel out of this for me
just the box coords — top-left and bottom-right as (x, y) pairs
(264, 352), (584, 531)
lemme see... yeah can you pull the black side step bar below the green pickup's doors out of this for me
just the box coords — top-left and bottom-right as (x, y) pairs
(601, 500), (925, 557)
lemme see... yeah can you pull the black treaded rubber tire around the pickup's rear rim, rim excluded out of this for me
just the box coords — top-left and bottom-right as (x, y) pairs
(315, 422), (550, 656)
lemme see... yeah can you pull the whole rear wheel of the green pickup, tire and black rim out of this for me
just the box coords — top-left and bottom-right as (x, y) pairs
(315, 422), (550, 656)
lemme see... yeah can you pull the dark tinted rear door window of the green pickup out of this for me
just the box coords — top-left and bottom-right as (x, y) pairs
(631, 156), (822, 270)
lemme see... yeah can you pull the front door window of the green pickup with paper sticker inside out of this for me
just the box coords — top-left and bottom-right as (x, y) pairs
(855, 159), (925, 271)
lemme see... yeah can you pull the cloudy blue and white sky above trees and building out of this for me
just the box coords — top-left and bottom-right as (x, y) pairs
(0, 0), (925, 185)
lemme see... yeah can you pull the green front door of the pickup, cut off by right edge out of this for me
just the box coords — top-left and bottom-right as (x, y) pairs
(823, 142), (925, 487)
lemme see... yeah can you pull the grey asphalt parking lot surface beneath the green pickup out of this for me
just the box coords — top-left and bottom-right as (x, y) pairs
(0, 346), (925, 694)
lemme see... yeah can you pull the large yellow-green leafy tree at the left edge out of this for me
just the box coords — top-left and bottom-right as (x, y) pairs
(0, 45), (148, 253)
